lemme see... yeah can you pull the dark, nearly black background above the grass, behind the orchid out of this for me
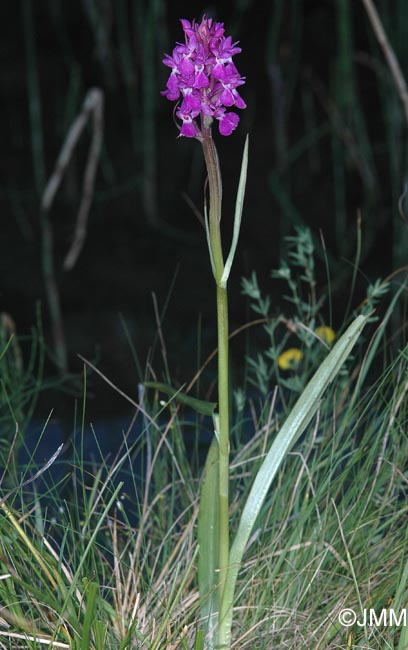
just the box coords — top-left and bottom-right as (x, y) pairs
(0, 0), (408, 415)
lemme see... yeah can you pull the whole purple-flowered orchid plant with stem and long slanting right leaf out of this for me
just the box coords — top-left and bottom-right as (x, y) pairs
(163, 16), (367, 650)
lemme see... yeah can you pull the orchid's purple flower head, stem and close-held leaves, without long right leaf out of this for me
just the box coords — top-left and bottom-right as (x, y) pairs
(162, 15), (248, 650)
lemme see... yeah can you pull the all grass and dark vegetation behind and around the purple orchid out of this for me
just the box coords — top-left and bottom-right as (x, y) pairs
(0, 0), (408, 650)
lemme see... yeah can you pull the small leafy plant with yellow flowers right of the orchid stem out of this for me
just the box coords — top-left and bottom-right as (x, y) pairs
(242, 227), (391, 397)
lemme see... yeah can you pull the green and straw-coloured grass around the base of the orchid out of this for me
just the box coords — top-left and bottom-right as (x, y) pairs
(0, 280), (408, 650)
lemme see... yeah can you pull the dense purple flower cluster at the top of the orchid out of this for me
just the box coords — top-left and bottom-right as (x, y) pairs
(162, 16), (246, 138)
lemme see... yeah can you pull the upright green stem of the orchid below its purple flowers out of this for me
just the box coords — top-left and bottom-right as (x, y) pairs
(201, 124), (230, 648)
